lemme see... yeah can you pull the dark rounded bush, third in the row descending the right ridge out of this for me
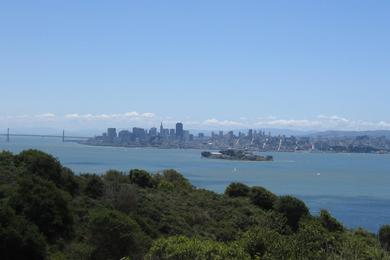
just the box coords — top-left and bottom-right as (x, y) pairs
(275, 196), (309, 230)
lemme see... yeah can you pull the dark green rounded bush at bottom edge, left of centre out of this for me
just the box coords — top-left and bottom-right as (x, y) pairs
(89, 208), (149, 260)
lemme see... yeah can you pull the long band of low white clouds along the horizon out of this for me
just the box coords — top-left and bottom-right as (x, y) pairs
(0, 111), (390, 131)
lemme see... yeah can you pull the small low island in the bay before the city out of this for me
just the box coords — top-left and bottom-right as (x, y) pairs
(201, 149), (274, 162)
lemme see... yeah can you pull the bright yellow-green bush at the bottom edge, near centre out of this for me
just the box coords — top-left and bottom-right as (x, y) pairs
(146, 236), (250, 260)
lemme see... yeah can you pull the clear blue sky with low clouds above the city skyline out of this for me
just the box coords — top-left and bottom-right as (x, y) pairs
(0, 0), (390, 130)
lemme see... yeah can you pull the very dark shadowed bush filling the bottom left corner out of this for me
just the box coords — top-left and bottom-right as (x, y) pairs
(0, 203), (46, 260)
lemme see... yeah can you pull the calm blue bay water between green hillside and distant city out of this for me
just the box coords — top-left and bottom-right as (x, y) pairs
(0, 137), (390, 232)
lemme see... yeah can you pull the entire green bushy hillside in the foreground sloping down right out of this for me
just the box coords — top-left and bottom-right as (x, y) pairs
(0, 150), (390, 260)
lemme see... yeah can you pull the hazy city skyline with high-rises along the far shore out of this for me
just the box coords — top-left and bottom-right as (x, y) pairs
(80, 122), (390, 153)
